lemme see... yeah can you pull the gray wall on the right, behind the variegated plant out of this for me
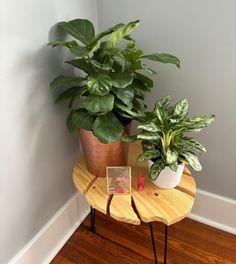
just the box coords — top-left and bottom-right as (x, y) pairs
(98, 0), (236, 199)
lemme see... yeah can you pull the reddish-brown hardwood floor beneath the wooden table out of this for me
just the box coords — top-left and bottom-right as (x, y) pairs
(51, 212), (236, 264)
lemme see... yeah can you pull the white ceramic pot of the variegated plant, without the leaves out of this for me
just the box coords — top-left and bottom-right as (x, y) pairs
(148, 160), (184, 189)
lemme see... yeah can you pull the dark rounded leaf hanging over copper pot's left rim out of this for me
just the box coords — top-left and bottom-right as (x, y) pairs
(71, 108), (95, 130)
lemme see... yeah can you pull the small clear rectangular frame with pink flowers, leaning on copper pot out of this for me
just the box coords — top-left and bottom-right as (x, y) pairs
(106, 166), (131, 194)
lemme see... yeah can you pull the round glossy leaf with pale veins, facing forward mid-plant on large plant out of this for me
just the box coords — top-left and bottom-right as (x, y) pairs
(87, 74), (112, 95)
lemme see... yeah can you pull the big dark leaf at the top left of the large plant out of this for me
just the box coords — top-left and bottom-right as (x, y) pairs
(59, 19), (95, 45)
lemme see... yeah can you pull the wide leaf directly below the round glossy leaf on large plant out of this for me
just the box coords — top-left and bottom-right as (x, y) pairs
(84, 94), (114, 113)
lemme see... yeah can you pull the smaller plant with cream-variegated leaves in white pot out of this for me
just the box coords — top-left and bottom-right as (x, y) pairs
(137, 96), (214, 188)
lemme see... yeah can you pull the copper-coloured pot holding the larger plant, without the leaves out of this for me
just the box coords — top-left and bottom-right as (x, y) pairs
(79, 124), (131, 177)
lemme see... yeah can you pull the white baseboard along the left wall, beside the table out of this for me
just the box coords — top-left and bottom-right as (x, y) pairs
(8, 193), (90, 264)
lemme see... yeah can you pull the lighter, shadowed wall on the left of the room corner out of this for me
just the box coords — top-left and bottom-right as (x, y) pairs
(0, 0), (97, 264)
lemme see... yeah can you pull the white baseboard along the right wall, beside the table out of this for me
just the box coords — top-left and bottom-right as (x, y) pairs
(189, 189), (236, 235)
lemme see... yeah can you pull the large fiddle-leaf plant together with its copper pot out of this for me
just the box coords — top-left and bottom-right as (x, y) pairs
(48, 19), (180, 176)
